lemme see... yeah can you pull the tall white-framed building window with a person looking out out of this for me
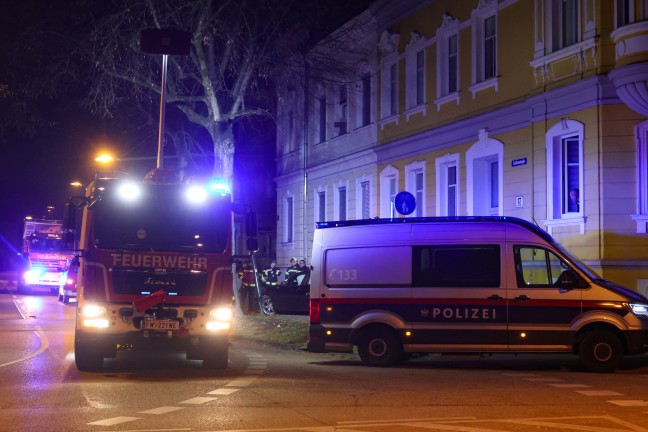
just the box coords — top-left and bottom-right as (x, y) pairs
(546, 119), (585, 232)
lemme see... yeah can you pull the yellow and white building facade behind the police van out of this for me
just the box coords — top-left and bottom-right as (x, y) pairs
(279, 0), (648, 289)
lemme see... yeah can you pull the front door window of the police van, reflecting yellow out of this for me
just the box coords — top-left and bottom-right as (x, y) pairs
(513, 246), (570, 288)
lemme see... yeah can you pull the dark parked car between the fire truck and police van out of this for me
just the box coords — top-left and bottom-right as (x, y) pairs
(259, 275), (310, 315)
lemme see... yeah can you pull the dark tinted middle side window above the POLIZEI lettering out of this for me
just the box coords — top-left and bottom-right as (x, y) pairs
(412, 245), (501, 288)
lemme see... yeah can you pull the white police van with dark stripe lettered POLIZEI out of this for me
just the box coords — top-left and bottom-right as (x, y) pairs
(308, 216), (648, 372)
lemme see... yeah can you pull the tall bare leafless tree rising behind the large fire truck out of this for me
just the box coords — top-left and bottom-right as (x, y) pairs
(82, 0), (306, 179)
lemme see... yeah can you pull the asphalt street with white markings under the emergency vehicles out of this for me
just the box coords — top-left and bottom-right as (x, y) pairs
(0, 291), (648, 432)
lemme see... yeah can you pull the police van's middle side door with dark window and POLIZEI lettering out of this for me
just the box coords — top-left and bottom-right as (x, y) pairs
(409, 242), (508, 352)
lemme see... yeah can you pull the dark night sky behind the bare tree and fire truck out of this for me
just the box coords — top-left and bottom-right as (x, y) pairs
(0, 0), (369, 270)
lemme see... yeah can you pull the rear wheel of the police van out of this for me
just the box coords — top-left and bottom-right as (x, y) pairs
(358, 327), (403, 366)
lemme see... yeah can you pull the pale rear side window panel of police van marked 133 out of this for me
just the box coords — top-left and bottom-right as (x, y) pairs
(324, 246), (412, 287)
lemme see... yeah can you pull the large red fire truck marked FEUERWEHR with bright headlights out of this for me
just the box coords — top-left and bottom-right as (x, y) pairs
(66, 168), (243, 371)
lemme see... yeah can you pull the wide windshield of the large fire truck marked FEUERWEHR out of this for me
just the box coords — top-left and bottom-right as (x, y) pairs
(90, 185), (231, 253)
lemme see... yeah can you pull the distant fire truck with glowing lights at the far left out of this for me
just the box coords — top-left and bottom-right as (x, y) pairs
(18, 217), (72, 293)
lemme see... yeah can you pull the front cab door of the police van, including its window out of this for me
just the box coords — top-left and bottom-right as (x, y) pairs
(508, 243), (588, 352)
